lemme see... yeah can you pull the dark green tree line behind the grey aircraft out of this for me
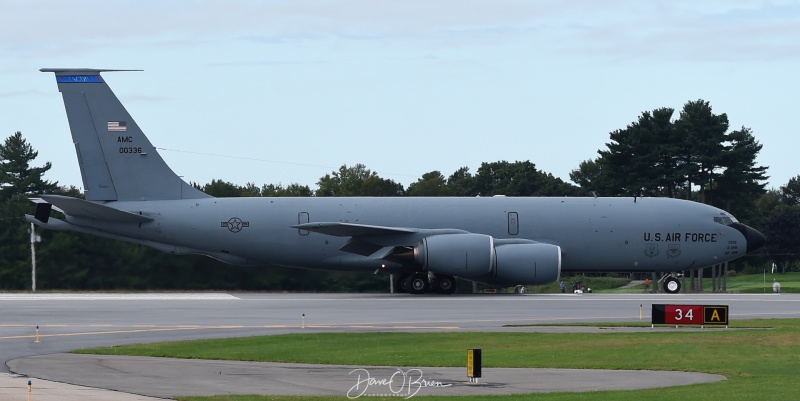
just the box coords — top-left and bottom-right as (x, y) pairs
(0, 100), (800, 292)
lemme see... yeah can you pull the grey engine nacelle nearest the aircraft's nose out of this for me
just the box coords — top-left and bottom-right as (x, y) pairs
(493, 244), (561, 285)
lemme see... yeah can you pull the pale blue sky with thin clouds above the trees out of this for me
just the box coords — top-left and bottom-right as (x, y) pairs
(0, 0), (800, 194)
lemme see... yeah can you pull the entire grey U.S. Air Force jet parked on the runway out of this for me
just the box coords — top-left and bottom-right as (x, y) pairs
(26, 68), (765, 293)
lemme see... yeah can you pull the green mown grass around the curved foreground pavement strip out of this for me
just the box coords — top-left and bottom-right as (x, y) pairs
(76, 319), (800, 401)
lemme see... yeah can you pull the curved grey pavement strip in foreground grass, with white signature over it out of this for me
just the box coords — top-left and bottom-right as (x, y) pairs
(7, 354), (725, 397)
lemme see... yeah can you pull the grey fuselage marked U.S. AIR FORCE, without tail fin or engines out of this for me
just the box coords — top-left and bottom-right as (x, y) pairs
(70, 197), (747, 272)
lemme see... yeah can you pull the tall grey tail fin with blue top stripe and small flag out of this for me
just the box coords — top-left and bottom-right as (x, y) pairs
(40, 68), (209, 201)
